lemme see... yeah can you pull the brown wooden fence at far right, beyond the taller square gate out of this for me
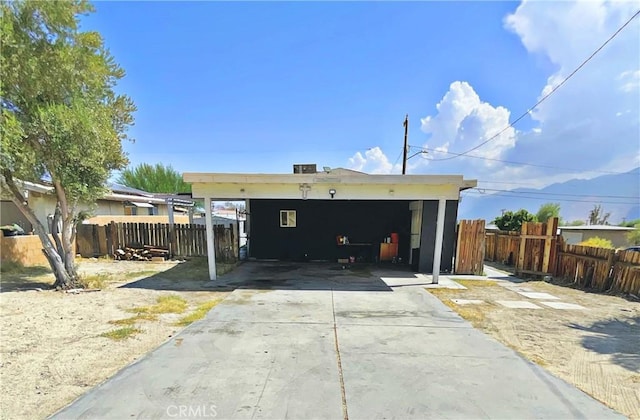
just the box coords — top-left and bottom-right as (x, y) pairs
(555, 244), (640, 296)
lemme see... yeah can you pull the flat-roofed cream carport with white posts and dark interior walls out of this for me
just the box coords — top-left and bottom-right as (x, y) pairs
(184, 165), (477, 280)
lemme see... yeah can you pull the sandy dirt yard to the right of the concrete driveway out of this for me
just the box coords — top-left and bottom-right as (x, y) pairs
(429, 268), (640, 419)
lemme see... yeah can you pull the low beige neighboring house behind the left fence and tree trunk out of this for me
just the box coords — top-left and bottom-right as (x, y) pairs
(0, 181), (194, 232)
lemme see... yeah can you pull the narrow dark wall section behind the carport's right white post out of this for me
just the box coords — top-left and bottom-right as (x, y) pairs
(418, 200), (458, 273)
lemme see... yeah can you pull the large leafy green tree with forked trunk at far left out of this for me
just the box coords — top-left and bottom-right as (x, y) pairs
(0, 0), (135, 289)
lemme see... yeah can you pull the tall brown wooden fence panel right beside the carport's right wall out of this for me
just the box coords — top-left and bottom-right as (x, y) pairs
(455, 220), (485, 276)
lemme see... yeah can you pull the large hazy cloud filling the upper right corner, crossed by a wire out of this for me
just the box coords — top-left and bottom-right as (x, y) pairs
(505, 1), (640, 176)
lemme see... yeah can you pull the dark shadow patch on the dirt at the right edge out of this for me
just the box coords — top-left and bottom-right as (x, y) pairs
(569, 316), (640, 373)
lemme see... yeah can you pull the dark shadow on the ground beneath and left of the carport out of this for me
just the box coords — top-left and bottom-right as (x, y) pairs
(120, 258), (420, 292)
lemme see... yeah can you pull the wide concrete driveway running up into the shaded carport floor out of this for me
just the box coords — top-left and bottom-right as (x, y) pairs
(54, 263), (621, 419)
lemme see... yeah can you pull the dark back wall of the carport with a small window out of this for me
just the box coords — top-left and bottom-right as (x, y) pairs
(249, 199), (412, 261)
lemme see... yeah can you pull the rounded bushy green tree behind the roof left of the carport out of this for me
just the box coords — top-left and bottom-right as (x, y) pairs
(118, 163), (191, 194)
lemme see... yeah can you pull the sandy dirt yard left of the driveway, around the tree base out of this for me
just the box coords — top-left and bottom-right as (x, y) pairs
(0, 260), (226, 419)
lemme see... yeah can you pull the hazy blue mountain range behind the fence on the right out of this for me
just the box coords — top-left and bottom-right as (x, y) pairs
(458, 168), (640, 224)
